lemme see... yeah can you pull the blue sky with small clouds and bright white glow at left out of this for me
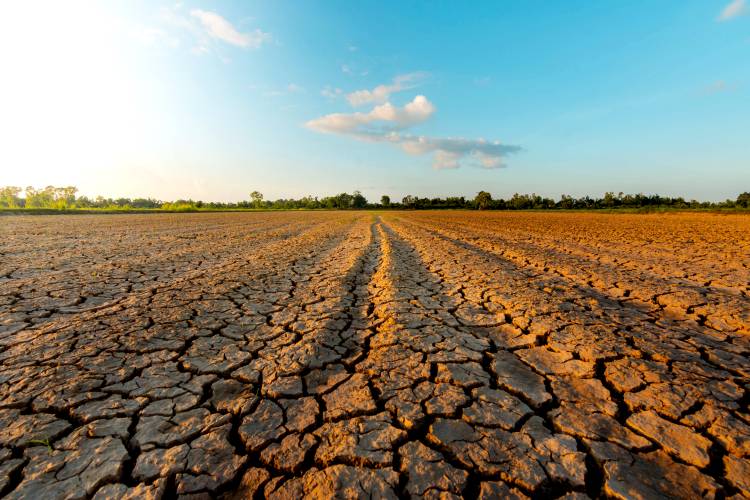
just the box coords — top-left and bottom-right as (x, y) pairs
(0, 0), (750, 201)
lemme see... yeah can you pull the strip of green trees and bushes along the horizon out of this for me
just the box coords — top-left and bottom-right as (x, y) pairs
(0, 186), (750, 211)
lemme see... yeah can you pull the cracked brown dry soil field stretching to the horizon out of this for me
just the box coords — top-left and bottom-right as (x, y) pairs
(0, 212), (750, 499)
